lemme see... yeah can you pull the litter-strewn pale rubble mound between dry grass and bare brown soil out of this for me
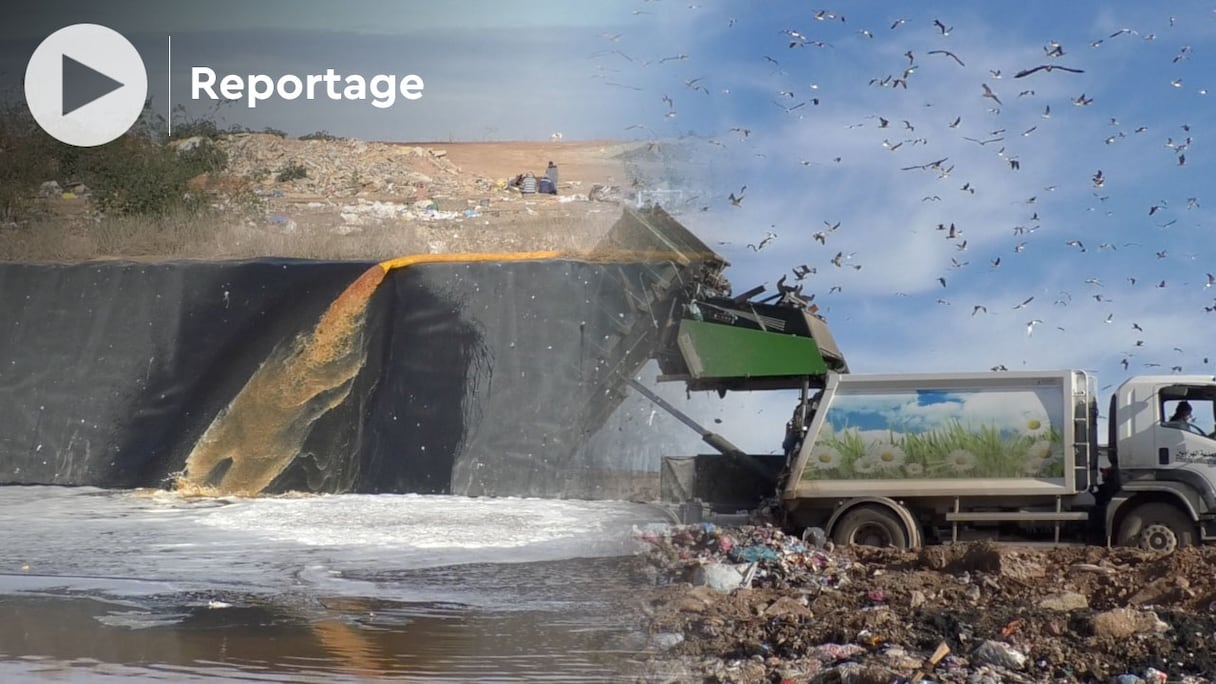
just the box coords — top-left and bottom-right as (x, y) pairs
(193, 133), (629, 252)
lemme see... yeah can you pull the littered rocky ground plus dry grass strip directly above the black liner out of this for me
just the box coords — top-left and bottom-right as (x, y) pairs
(7, 133), (695, 260)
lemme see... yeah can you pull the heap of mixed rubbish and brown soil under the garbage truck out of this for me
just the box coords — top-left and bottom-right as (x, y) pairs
(632, 523), (1216, 684)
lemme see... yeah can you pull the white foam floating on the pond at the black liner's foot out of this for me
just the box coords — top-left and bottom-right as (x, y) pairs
(0, 487), (662, 595)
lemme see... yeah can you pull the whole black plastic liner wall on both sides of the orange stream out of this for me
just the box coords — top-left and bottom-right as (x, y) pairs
(0, 253), (700, 498)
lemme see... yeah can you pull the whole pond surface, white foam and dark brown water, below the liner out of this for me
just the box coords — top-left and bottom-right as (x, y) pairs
(0, 487), (662, 683)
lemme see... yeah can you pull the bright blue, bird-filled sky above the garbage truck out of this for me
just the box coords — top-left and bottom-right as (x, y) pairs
(573, 1), (1216, 386)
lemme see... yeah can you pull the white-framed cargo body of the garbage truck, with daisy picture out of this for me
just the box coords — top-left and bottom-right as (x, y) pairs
(784, 370), (1096, 500)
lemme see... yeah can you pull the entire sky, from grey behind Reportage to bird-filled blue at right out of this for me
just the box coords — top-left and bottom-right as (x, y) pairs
(9, 0), (1216, 450)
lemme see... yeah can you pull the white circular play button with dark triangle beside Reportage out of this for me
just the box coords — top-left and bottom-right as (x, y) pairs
(26, 24), (148, 147)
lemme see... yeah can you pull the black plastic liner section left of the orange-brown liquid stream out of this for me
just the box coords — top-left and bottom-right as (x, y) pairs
(0, 262), (368, 487)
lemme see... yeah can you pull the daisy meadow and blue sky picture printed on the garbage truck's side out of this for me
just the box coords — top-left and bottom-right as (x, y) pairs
(803, 387), (1064, 481)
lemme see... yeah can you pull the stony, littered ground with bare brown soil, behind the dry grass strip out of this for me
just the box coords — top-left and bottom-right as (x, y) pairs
(192, 134), (666, 256)
